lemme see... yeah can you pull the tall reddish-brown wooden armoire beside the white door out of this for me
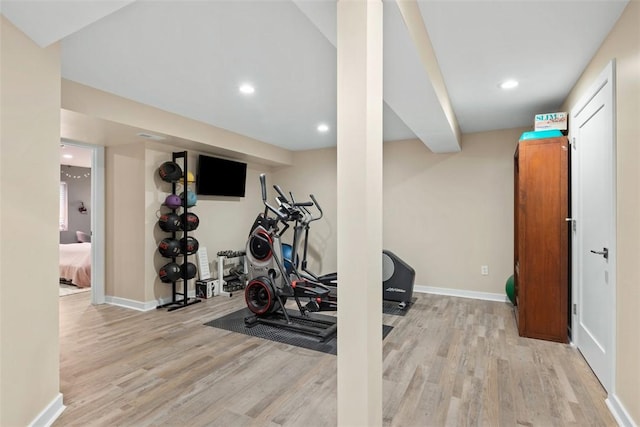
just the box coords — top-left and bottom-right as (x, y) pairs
(514, 136), (571, 343)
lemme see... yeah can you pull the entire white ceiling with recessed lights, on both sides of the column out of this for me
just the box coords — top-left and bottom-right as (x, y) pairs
(0, 0), (627, 152)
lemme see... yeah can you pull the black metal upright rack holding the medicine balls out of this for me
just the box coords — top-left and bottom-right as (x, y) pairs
(156, 151), (201, 311)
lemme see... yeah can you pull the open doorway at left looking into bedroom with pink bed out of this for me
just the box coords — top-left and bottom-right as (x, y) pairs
(60, 139), (105, 304)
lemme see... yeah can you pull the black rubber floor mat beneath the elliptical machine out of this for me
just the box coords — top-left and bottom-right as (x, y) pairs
(205, 308), (393, 354)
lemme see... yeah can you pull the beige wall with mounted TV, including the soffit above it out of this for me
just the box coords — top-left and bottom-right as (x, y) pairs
(62, 67), (292, 305)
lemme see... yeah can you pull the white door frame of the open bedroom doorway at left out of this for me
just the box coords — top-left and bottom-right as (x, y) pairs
(60, 138), (106, 304)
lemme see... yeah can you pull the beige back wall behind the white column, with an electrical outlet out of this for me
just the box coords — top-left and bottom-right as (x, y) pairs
(273, 129), (525, 295)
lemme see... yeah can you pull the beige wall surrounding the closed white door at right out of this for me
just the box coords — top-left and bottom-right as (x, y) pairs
(563, 1), (640, 425)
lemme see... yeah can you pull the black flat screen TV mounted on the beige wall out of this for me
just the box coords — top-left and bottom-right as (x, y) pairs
(196, 154), (247, 197)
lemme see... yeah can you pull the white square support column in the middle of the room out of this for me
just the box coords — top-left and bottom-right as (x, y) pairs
(337, 0), (382, 427)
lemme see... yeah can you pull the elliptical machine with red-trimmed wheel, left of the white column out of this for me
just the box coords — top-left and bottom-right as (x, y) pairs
(245, 174), (337, 341)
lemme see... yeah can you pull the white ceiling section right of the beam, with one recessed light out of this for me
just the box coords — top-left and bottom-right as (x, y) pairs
(419, 0), (627, 133)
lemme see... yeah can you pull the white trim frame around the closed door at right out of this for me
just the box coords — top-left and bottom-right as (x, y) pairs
(569, 59), (617, 396)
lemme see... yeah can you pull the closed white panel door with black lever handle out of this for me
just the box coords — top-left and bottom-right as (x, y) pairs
(571, 62), (616, 391)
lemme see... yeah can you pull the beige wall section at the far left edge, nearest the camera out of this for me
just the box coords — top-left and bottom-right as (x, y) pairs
(0, 17), (60, 426)
